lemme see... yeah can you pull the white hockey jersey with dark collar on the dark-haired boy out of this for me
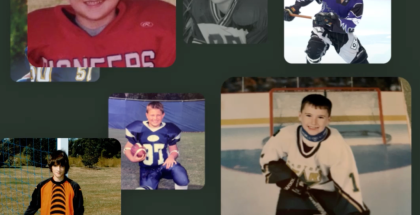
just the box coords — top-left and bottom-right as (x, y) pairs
(260, 125), (367, 214)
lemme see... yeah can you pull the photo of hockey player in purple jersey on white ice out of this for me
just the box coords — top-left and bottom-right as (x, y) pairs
(284, 0), (391, 64)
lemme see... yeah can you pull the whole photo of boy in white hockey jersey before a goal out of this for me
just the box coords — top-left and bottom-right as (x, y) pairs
(221, 77), (412, 215)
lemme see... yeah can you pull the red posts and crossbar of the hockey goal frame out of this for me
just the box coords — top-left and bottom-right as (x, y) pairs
(269, 87), (387, 144)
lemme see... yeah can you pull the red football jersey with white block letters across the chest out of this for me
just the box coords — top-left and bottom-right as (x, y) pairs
(28, 0), (176, 67)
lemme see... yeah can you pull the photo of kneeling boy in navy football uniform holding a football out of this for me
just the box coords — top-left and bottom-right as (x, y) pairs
(108, 93), (204, 190)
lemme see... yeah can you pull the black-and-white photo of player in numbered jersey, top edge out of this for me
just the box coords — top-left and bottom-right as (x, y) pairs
(183, 0), (268, 44)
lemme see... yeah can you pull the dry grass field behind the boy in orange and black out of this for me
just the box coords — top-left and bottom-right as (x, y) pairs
(0, 166), (121, 215)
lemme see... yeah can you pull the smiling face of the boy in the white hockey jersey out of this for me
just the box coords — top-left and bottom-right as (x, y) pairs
(299, 104), (330, 135)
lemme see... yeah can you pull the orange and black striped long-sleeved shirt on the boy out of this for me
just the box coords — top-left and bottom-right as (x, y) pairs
(25, 177), (85, 215)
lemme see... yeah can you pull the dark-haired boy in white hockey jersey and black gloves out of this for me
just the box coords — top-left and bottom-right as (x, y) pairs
(260, 94), (370, 214)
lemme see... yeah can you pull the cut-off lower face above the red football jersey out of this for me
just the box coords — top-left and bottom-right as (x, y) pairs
(68, 0), (120, 21)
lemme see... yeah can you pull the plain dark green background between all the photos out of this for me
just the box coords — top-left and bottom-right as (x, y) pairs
(0, 0), (420, 215)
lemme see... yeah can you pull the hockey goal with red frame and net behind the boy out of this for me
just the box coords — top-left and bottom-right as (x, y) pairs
(269, 87), (391, 144)
